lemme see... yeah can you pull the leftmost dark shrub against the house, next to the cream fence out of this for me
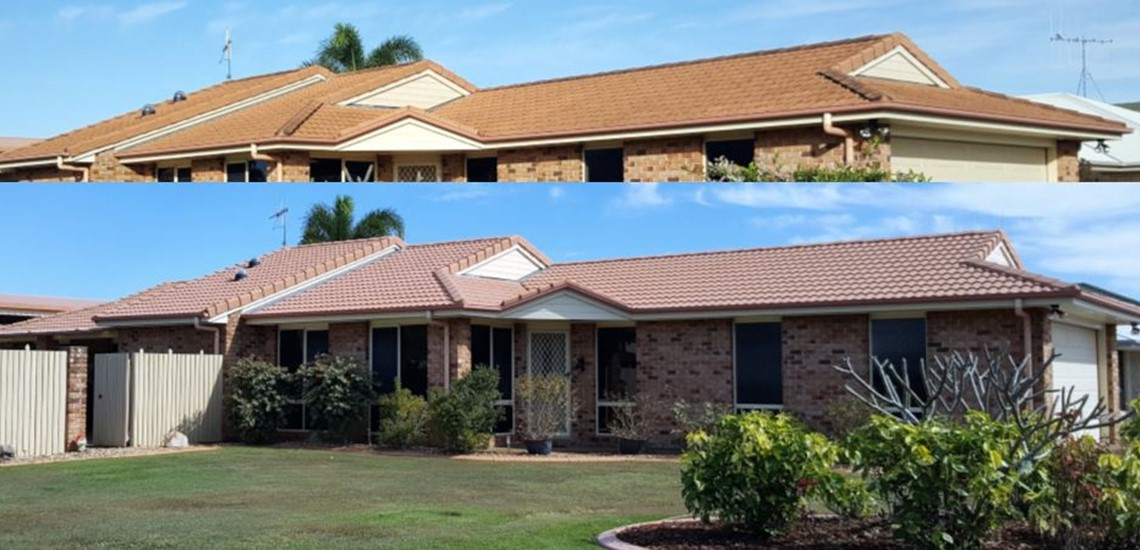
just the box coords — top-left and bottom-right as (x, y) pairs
(226, 358), (287, 444)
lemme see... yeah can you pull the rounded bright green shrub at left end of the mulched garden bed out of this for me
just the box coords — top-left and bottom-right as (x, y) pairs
(681, 412), (839, 537)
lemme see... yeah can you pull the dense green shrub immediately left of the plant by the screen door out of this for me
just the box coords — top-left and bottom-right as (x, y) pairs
(428, 365), (503, 453)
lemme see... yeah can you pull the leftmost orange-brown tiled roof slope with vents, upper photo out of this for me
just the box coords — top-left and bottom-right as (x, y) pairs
(0, 66), (332, 163)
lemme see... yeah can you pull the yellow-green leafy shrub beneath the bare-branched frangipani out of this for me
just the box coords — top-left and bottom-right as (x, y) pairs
(849, 411), (1018, 549)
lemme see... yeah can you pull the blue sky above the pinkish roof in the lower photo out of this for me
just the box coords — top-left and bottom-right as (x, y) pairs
(0, 184), (1140, 299)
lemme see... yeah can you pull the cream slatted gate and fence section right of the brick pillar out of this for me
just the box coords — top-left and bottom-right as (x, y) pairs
(91, 353), (222, 447)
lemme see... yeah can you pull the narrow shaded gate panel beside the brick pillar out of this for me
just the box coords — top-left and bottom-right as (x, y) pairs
(89, 354), (131, 447)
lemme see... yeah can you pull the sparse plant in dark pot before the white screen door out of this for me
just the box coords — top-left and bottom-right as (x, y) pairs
(515, 374), (573, 455)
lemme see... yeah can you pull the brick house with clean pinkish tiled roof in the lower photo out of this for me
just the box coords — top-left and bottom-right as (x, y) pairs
(0, 232), (1140, 443)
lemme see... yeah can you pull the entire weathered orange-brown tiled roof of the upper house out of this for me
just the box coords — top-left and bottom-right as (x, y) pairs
(0, 34), (1129, 163)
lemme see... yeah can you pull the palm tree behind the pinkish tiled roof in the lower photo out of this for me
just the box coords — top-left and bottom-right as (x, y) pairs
(301, 195), (404, 244)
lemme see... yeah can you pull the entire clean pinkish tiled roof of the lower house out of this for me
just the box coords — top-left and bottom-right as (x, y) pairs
(0, 232), (1140, 337)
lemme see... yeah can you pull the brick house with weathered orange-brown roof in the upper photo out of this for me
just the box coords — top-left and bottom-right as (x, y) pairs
(0, 34), (1131, 181)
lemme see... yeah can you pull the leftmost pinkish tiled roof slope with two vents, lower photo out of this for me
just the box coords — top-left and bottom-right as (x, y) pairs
(96, 237), (404, 323)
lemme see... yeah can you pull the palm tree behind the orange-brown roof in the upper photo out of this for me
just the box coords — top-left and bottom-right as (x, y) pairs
(304, 23), (424, 73)
